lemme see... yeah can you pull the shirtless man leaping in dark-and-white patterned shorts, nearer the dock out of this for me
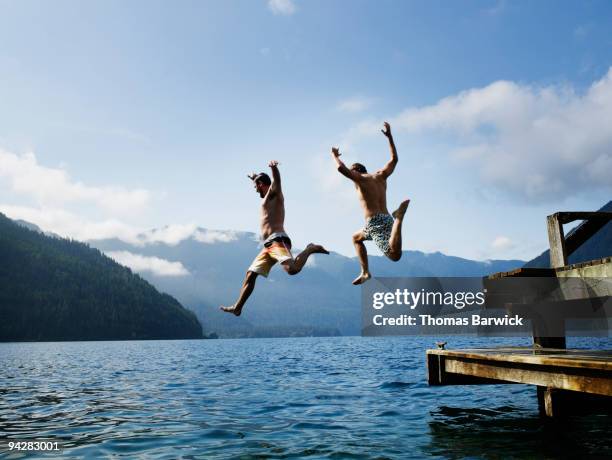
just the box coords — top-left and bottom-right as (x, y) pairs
(332, 122), (410, 285)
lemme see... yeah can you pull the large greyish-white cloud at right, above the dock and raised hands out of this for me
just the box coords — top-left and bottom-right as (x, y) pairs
(347, 68), (612, 203)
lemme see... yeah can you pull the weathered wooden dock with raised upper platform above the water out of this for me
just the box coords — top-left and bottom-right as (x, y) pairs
(426, 212), (612, 417)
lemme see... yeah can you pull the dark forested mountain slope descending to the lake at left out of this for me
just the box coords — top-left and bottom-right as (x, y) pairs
(0, 214), (202, 341)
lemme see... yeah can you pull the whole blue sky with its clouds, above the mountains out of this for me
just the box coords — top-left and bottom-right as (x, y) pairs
(0, 0), (612, 263)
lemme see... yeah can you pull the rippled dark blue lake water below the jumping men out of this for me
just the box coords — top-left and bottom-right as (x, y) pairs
(0, 337), (612, 459)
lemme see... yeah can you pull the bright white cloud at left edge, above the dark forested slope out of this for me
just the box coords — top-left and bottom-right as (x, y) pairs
(0, 150), (149, 212)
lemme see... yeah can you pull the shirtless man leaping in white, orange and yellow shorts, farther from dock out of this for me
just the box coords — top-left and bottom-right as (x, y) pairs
(221, 161), (329, 316)
